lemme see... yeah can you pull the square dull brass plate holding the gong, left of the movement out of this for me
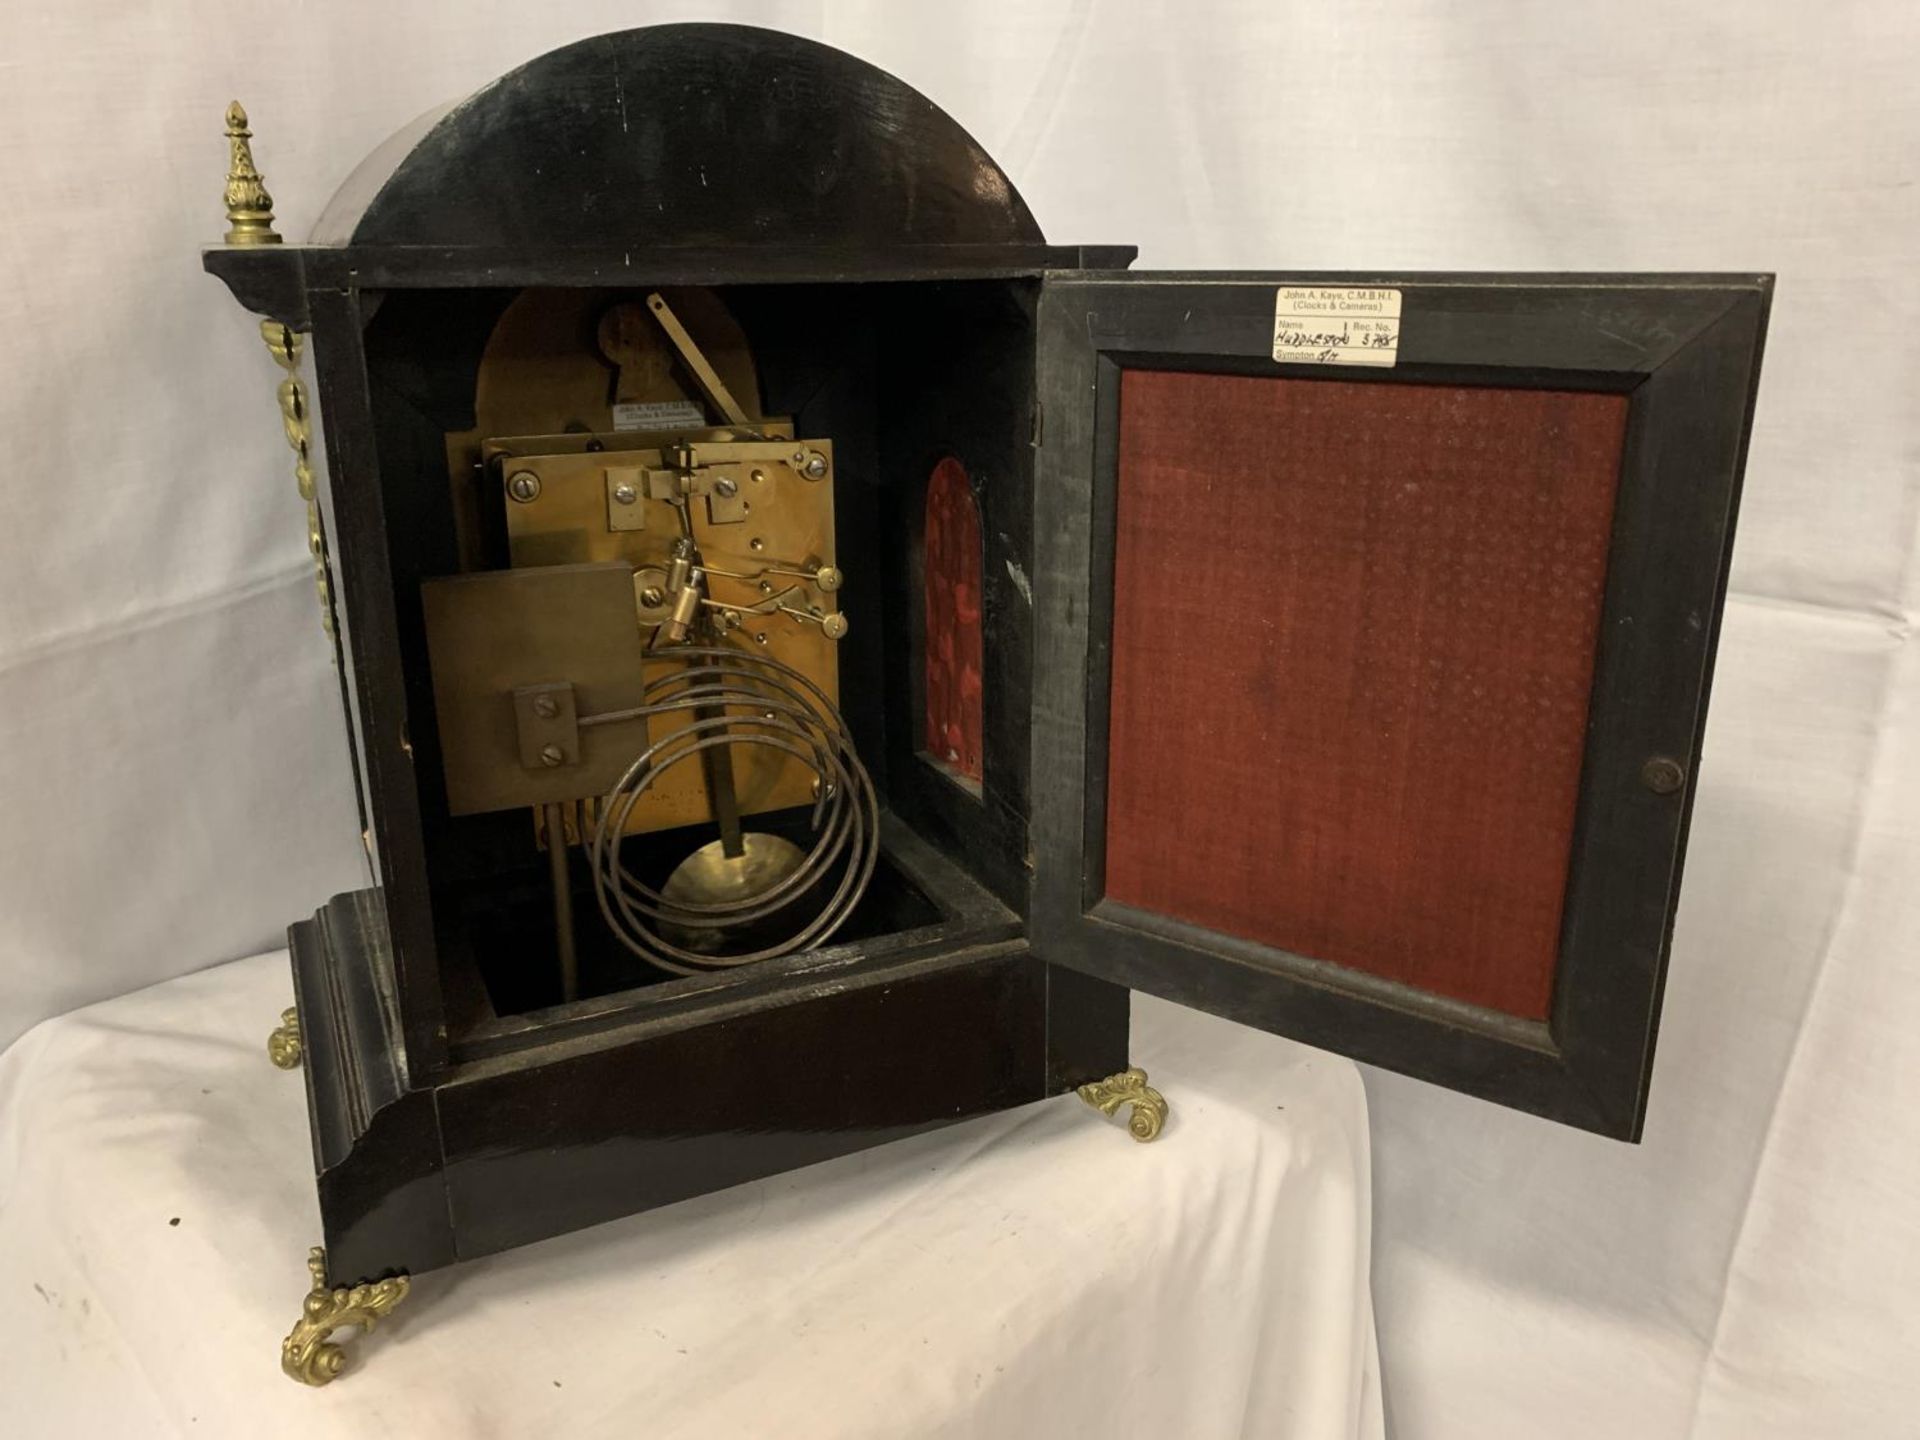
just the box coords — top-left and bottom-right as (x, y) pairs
(420, 564), (647, 814)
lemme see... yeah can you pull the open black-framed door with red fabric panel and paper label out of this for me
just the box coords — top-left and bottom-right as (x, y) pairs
(1031, 273), (1770, 1139)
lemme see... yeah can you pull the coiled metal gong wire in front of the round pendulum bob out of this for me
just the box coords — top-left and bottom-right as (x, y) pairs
(588, 645), (879, 975)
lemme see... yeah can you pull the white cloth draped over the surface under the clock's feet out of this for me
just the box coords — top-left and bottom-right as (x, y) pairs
(0, 954), (1384, 1440)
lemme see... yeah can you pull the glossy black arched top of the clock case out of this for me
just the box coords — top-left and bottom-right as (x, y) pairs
(313, 25), (1044, 252)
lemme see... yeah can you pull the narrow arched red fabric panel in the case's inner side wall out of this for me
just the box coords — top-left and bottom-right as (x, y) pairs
(922, 457), (983, 781)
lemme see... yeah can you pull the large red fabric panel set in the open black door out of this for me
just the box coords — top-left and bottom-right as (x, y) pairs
(1106, 371), (1626, 1020)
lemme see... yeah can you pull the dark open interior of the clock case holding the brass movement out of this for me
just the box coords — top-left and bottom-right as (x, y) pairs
(365, 280), (1037, 1043)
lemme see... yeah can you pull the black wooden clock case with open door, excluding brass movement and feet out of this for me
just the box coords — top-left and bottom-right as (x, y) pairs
(205, 25), (1768, 1284)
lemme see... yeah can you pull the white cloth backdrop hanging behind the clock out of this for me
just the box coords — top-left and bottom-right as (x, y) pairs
(0, 0), (1920, 1440)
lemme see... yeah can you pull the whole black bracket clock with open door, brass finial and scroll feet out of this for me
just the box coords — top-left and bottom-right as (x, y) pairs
(205, 25), (1770, 1384)
